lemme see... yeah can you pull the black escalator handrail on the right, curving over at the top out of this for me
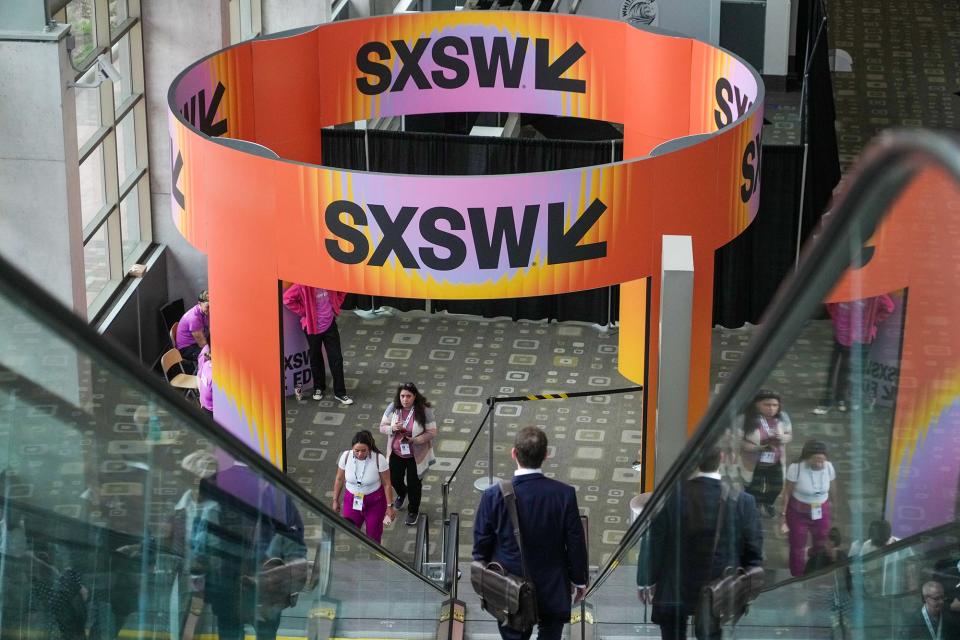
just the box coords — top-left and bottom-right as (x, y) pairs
(586, 130), (960, 598)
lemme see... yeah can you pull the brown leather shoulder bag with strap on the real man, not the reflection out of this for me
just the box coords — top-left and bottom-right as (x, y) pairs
(470, 480), (537, 633)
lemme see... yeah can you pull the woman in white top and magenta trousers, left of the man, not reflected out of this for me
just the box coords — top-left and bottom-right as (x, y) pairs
(333, 430), (397, 544)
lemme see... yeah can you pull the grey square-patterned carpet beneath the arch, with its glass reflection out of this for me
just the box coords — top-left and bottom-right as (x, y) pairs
(287, 312), (889, 577)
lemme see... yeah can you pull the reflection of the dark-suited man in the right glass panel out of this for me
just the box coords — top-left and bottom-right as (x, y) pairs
(637, 447), (763, 640)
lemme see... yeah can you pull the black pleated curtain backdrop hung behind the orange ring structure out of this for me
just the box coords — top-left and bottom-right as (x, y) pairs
(322, 129), (803, 327)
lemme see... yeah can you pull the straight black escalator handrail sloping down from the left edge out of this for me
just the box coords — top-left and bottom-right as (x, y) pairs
(0, 256), (447, 595)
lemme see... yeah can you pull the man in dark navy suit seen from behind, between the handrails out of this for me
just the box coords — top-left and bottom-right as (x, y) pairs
(473, 427), (587, 640)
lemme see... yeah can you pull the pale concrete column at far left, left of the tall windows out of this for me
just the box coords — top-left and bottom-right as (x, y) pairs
(0, 25), (87, 318)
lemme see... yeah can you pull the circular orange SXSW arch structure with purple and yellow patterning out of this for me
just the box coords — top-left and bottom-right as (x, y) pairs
(169, 11), (763, 473)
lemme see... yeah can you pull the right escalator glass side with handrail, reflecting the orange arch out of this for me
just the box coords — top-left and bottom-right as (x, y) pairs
(587, 132), (960, 638)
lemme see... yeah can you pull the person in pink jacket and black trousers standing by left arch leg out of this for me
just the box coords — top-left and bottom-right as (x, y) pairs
(283, 284), (353, 405)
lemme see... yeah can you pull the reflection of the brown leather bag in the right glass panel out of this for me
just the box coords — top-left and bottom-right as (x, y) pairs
(695, 486), (764, 629)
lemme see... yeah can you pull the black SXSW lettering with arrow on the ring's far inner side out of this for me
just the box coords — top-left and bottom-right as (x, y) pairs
(357, 36), (587, 96)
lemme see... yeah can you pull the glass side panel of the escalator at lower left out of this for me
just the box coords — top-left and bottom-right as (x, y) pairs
(0, 263), (447, 640)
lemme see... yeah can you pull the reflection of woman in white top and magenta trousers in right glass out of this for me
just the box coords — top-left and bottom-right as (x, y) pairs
(782, 440), (837, 576)
